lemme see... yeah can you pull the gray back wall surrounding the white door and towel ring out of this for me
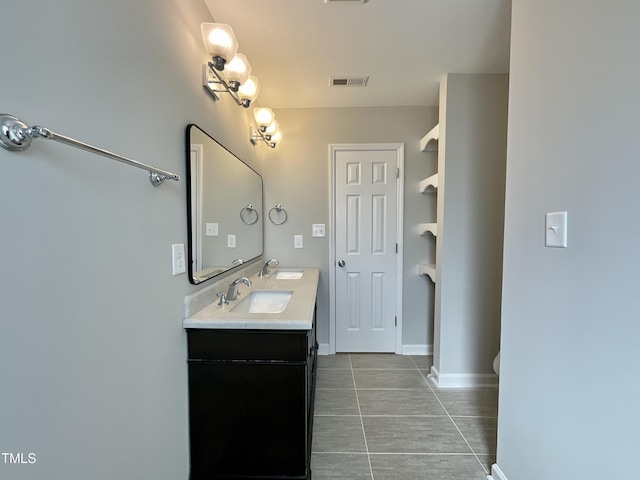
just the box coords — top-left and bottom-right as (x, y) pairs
(263, 107), (438, 345)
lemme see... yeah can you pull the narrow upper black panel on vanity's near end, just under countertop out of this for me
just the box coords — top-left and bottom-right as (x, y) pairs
(187, 329), (310, 362)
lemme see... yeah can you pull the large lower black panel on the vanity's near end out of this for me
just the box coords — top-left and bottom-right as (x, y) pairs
(189, 361), (308, 480)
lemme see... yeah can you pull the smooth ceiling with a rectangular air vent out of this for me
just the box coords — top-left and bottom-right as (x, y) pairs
(205, 0), (511, 108)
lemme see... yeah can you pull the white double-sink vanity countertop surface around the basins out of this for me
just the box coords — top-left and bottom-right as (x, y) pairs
(182, 267), (320, 330)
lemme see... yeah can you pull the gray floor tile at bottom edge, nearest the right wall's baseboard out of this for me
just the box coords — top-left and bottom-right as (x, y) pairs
(371, 455), (486, 480)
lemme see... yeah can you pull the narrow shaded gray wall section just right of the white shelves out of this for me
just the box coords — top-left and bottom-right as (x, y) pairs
(434, 74), (509, 386)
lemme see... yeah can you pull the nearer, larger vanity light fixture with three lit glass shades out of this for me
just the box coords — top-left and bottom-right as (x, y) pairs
(200, 23), (259, 108)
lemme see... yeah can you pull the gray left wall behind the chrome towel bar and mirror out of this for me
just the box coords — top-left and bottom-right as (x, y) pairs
(0, 0), (261, 480)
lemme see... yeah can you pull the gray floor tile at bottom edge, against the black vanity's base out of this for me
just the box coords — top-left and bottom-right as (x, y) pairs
(311, 453), (371, 480)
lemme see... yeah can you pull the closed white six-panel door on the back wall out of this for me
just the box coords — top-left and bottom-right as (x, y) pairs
(334, 150), (398, 352)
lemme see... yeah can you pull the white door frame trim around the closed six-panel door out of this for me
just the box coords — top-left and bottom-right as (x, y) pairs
(328, 143), (404, 354)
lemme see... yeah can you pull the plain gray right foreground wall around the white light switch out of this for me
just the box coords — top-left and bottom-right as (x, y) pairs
(497, 0), (640, 480)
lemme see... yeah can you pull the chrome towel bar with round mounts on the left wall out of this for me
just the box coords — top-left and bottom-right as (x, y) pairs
(0, 113), (180, 187)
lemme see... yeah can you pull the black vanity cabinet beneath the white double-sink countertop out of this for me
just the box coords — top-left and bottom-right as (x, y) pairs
(187, 318), (318, 480)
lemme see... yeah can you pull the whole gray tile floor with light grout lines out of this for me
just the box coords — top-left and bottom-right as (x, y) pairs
(311, 354), (498, 480)
